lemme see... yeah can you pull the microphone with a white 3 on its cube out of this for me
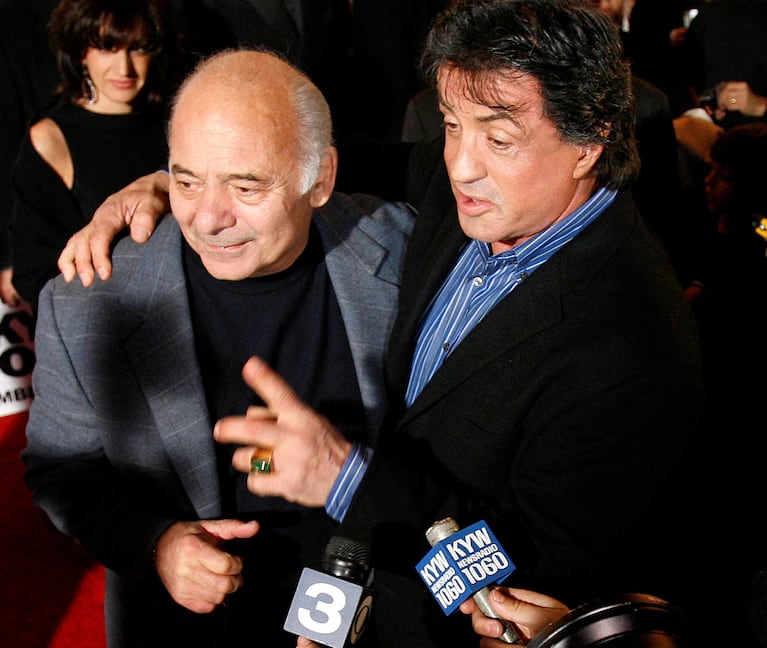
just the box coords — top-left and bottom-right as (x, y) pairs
(283, 536), (373, 648)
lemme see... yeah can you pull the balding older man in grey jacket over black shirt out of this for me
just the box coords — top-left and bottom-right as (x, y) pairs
(23, 50), (412, 648)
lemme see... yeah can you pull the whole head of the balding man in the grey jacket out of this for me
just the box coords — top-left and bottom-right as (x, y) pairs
(168, 50), (337, 281)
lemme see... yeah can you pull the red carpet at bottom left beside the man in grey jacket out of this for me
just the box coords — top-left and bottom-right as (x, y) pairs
(0, 412), (106, 648)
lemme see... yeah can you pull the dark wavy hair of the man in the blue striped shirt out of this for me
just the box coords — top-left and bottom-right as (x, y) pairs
(420, 0), (639, 189)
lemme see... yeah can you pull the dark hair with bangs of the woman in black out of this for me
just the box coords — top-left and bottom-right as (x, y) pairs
(48, 0), (180, 108)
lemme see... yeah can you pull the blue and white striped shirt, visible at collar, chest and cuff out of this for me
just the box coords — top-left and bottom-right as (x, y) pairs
(325, 189), (617, 521)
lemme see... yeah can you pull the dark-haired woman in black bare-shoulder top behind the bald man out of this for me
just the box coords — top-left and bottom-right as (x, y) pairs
(10, 0), (181, 309)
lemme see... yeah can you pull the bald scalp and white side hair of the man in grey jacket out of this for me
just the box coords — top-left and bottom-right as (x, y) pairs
(169, 50), (333, 191)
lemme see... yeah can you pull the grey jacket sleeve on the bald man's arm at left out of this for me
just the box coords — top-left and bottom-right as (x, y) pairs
(21, 281), (176, 577)
